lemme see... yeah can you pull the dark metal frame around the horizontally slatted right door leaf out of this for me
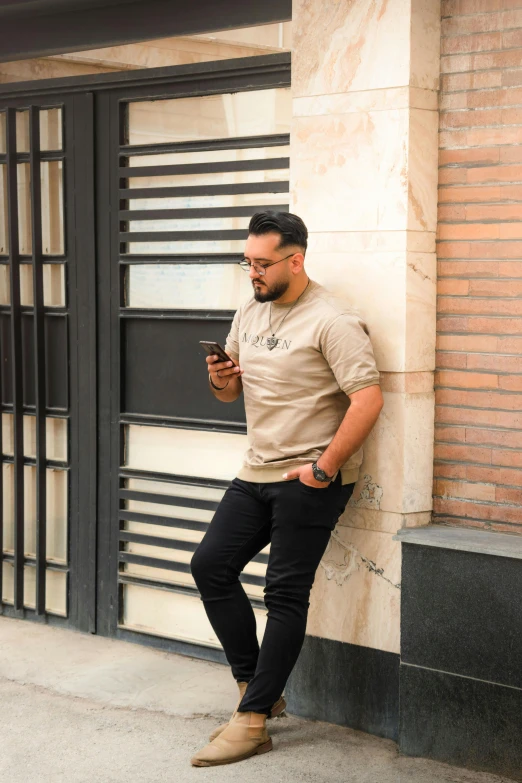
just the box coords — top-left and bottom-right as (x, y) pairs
(96, 54), (290, 662)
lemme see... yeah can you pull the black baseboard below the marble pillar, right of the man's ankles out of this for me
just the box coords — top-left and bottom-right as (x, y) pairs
(285, 636), (399, 740)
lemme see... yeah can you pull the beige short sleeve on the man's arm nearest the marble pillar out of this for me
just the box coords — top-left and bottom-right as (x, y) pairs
(321, 313), (379, 394)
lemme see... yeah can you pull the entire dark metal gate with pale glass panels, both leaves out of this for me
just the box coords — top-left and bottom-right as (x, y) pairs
(0, 54), (291, 658)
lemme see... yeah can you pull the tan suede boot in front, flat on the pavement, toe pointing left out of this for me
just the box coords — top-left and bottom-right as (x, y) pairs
(190, 712), (272, 767)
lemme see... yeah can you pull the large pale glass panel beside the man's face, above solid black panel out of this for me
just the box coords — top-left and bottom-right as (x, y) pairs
(127, 264), (252, 310)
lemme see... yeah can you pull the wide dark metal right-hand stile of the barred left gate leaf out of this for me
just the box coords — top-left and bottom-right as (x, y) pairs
(69, 93), (98, 633)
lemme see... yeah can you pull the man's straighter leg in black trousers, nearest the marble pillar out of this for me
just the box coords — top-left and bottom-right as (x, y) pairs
(238, 477), (354, 715)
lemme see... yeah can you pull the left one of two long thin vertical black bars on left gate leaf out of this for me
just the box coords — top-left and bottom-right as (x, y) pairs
(6, 109), (24, 614)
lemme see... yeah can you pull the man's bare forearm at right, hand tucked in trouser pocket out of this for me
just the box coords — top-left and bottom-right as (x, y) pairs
(283, 385), (384, 487)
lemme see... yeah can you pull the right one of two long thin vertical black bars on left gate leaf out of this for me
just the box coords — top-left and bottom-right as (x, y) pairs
(29, 106), (47, 615)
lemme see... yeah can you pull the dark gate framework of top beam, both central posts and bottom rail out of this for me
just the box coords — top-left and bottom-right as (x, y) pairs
(0, 53), (291, 648)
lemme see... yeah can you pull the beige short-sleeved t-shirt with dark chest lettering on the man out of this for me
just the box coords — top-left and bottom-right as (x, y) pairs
(226, 280), (379, 484)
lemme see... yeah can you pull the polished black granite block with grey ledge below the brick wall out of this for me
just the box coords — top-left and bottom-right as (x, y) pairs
(398, 526), (522, 781)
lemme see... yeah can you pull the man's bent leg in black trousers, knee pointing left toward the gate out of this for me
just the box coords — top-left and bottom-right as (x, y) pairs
(191, 479), (268, 684)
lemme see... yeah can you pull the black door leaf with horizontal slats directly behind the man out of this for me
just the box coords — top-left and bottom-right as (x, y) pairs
(96, 55), (291, 657)
